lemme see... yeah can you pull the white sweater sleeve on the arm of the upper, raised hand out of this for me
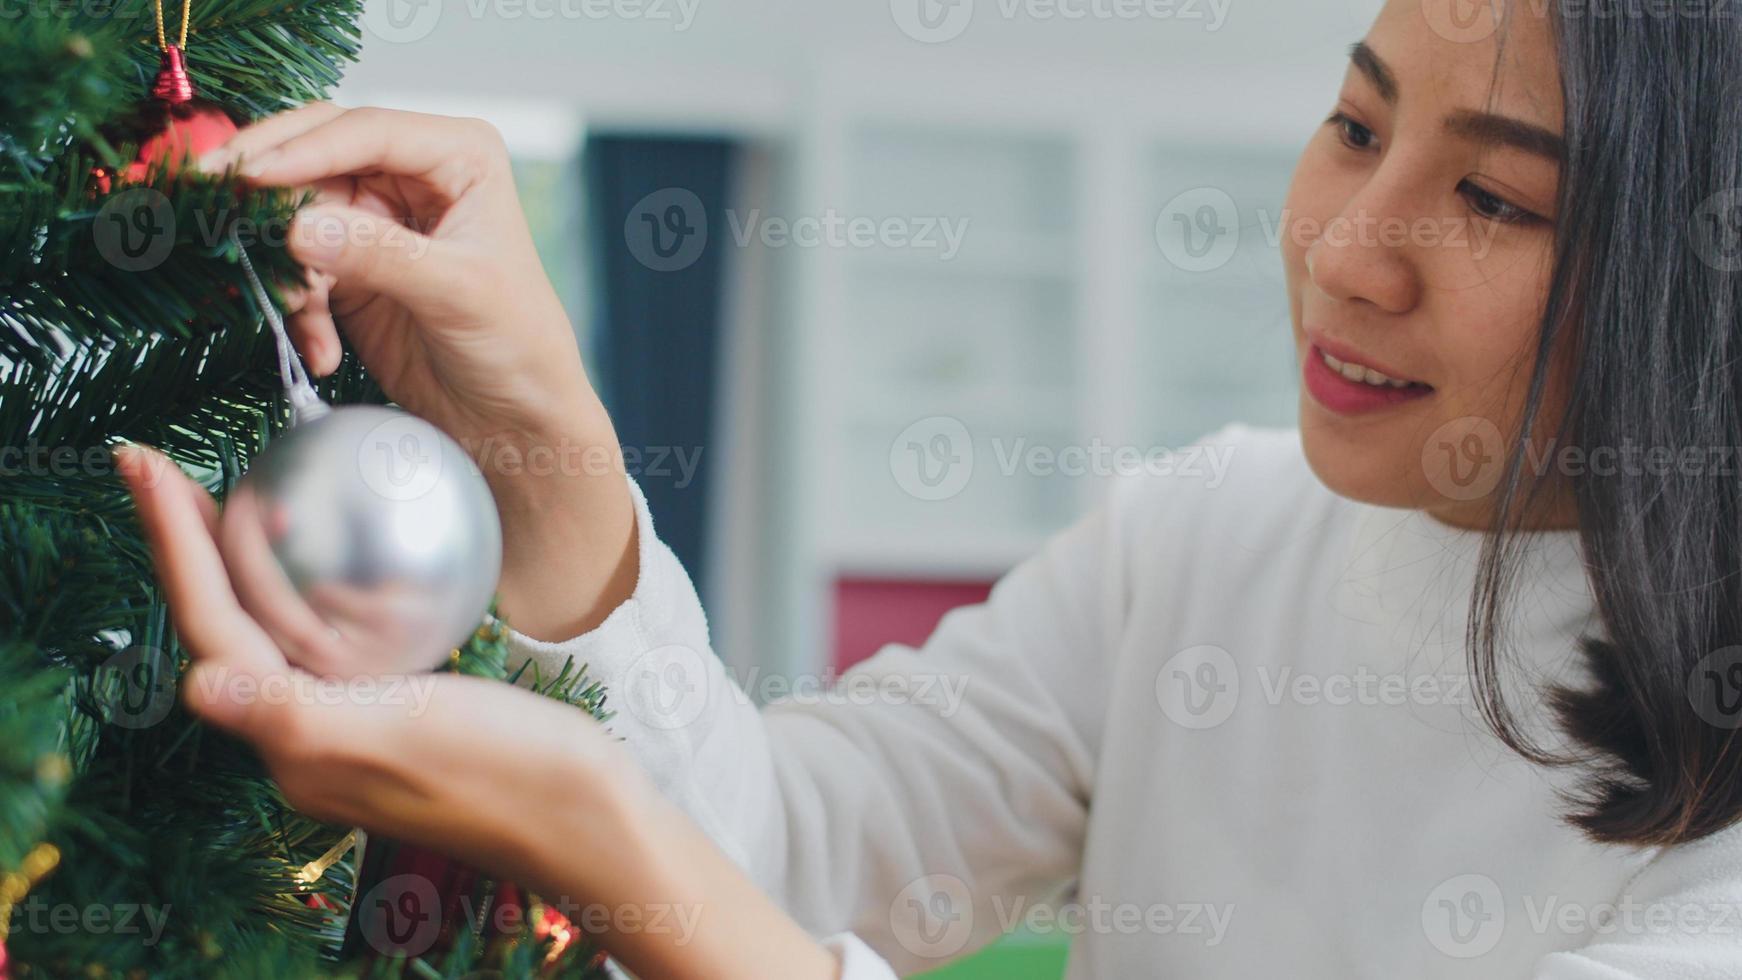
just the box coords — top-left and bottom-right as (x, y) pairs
(510, 476), (1120, 980)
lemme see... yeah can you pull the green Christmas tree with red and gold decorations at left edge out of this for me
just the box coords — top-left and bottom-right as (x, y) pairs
(0, 0), (603, 980)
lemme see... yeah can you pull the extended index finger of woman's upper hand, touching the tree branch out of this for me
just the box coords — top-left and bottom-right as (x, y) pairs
(228, 108), (500, 197)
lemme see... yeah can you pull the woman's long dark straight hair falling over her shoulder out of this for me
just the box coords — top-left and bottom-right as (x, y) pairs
(1469, 0), (1742, 844)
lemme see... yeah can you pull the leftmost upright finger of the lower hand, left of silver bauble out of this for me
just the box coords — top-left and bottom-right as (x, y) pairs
(115, 446), (284, 672)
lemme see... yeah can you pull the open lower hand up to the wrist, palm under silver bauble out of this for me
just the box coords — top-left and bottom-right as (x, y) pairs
(115, 440), (627, 876)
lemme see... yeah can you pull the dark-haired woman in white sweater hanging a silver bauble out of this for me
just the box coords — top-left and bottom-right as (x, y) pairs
(124, 0), (1742, 980)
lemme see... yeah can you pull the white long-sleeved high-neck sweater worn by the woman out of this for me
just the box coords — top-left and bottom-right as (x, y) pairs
(514, 428), (1742, 980)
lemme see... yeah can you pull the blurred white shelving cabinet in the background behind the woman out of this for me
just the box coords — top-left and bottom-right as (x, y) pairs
(760, 64), (1301, 685)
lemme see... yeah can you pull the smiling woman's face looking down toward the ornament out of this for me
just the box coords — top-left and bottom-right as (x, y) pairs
(1282, 0), (1563, 527)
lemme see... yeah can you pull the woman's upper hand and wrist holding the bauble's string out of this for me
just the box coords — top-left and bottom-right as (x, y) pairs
(200, 103), (636, 639)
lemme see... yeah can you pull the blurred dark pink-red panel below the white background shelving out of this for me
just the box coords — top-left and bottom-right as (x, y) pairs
(834, 578), (991, 670)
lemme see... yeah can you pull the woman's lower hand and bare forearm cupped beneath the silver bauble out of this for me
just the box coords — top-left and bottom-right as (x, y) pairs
(117, 449), (840, 980)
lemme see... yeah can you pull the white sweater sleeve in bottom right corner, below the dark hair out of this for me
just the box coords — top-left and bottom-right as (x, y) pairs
(1533, 827), (1742, 980)
